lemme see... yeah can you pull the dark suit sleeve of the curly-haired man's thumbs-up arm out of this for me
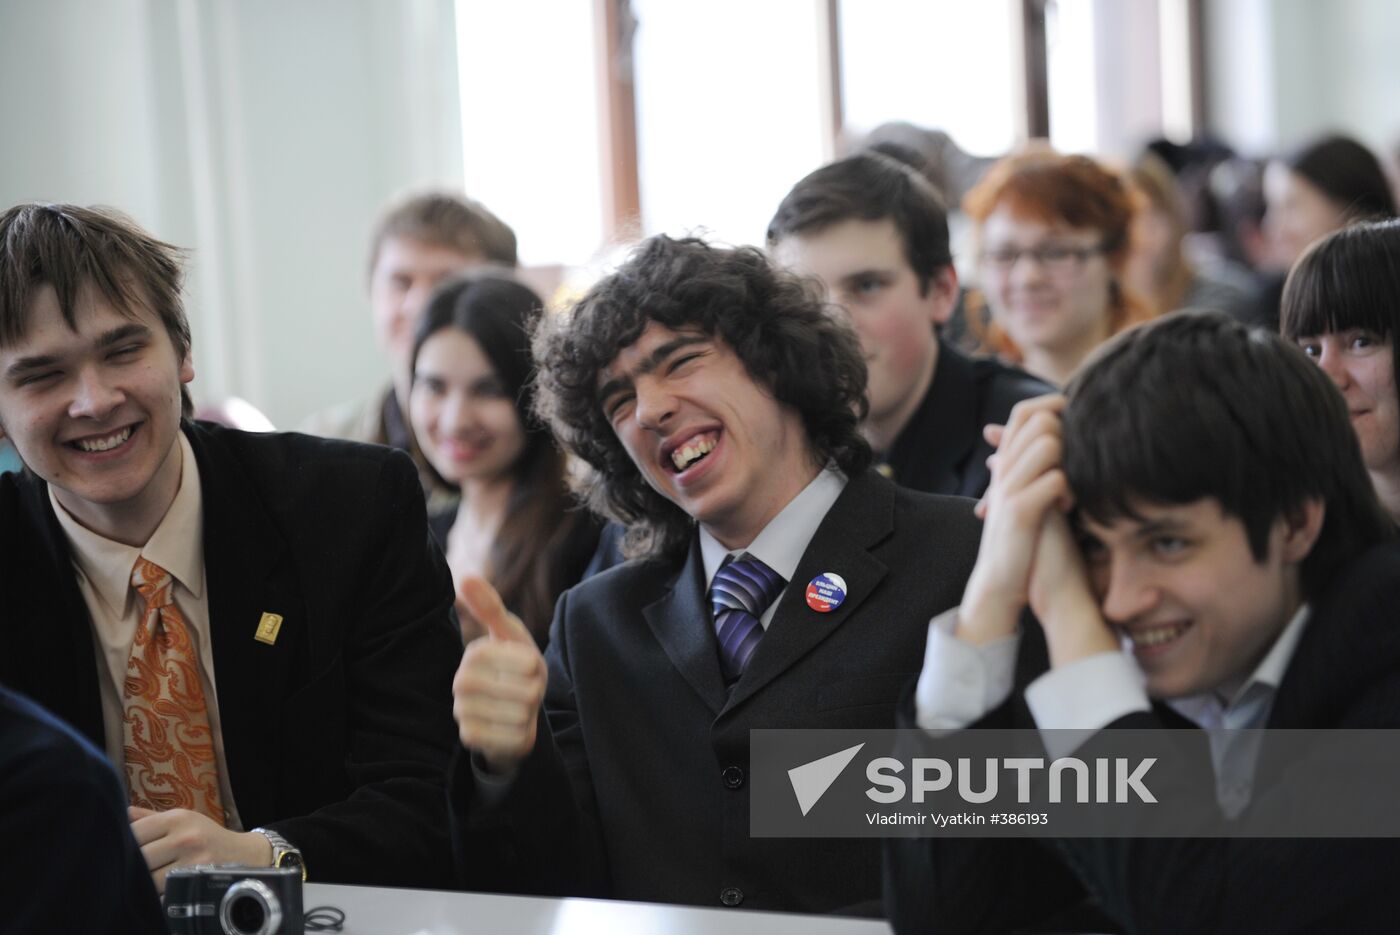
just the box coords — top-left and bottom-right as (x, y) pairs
(449, 591), (608, 896)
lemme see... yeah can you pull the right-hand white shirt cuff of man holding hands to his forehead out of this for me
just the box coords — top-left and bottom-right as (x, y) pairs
(1026, 651), (1152, 757)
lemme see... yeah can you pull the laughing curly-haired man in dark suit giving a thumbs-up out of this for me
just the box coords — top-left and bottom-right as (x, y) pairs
(449, 237), (979, 913)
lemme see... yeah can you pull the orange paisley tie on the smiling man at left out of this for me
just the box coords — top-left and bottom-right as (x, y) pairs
(122, 558), (225, 824)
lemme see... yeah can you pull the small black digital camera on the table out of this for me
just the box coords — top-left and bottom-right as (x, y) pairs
(165, 865), (305, 935)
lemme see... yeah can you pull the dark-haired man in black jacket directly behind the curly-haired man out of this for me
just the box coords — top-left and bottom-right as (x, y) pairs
(767, 153), (1053, 497)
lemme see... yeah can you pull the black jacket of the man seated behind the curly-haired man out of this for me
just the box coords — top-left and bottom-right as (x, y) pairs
(885, 339), (1056, 497)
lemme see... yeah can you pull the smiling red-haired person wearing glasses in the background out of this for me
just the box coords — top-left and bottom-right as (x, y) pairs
(963, 148), (1149, 386)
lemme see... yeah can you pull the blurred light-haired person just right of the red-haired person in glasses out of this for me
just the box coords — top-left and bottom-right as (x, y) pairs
(1123, 151), (1254, 318)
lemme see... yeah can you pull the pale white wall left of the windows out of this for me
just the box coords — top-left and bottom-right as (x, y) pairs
(0, 0), (461, 427)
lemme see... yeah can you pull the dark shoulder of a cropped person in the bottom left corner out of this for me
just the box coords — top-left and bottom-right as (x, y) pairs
(0, 691), (165, 935)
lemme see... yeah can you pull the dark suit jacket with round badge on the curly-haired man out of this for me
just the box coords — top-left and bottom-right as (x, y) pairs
(452, 472), (980, 911)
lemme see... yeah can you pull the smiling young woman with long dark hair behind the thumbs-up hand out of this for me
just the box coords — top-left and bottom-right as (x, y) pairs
(409, 274), (599, 647)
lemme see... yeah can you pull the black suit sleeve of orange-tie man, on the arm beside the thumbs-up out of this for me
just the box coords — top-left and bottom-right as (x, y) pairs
(269, 454), (462, 887)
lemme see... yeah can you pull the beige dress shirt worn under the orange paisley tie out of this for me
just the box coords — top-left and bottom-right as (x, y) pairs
(49, 433), (244, 831)
